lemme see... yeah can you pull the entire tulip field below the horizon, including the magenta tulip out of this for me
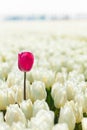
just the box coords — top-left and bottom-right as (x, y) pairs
(0, 20), (87, 130)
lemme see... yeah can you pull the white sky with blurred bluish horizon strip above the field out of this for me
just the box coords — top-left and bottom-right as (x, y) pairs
(0, 0), (87, 20)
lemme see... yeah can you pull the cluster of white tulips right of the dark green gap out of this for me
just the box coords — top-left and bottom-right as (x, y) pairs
(51, 72), (87, 130)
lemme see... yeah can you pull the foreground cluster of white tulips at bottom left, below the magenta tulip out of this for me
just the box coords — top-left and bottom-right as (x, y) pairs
(0, 99), (54, 130)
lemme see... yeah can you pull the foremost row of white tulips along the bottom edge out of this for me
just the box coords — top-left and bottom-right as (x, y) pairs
(0, 99), (87, 130)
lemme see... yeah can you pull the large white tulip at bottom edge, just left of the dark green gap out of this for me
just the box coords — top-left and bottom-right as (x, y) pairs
(28, 110), (54, 130)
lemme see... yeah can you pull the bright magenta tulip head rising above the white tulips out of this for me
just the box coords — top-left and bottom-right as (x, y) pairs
(18, 52), (34, 72)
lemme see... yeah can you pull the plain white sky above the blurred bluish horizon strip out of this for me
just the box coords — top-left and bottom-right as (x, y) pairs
(0, 0), (87, 16)
